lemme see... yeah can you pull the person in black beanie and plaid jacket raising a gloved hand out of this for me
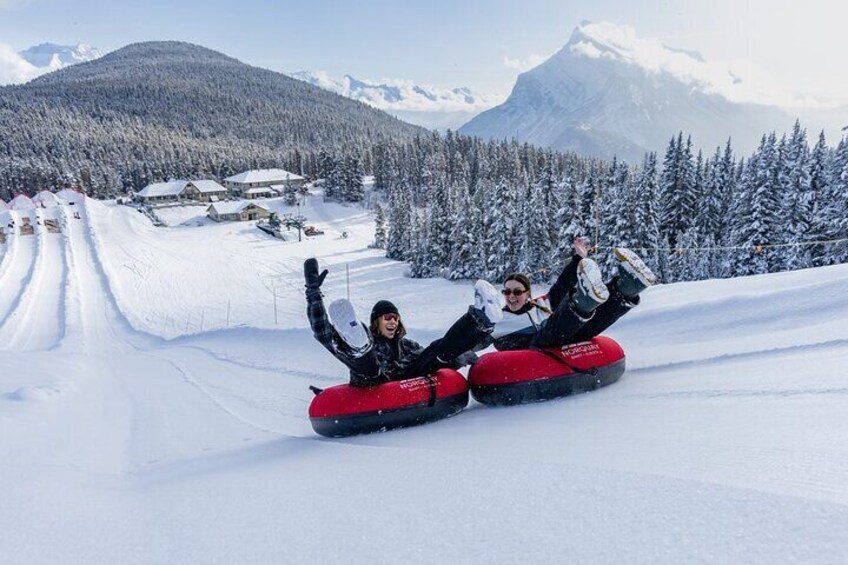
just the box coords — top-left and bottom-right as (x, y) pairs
(304, 259), (503, 386)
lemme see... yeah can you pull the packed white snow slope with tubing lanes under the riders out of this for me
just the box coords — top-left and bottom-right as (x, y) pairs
(0, 192), (848, 564)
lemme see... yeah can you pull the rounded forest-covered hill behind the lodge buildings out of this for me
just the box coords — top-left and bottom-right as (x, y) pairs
(0, 41), (427, 195)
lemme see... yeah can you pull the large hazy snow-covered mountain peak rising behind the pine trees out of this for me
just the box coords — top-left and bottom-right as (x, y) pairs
(459, 23), (848, 162)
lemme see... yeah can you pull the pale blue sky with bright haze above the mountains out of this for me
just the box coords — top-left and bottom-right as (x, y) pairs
(0, 0), (848, 98)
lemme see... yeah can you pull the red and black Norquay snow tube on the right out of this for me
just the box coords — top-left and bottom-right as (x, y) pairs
(468, 336), (624, 406)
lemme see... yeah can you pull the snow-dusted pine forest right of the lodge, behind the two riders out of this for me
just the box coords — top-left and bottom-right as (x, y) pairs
(378, 123), (848, 282)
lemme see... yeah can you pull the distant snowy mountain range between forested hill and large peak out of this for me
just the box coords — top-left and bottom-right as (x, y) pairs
(289, 71), (503, 130)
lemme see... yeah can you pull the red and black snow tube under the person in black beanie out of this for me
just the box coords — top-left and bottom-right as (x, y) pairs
(309, 369), (468, 437)
